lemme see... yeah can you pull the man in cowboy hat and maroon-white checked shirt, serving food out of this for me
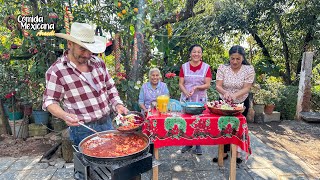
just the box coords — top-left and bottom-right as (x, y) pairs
(43, 22), (128, 145)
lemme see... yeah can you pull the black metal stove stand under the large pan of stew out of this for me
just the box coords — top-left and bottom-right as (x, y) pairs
(73, 152), (152, 180)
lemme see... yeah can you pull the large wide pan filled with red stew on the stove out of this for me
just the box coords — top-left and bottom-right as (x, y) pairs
(74, 130), (150, 162)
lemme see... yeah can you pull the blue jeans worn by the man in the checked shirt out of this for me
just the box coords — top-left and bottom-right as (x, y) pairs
(69, 115), (114, 146)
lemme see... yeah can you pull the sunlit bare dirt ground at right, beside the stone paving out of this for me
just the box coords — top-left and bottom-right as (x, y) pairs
(248, 120), (320, 169)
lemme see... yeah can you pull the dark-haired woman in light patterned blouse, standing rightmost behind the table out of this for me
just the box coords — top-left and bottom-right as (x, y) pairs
(212, 45), (255, 163)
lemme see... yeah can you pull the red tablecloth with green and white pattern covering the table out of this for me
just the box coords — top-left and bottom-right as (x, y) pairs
(142, 107), (251, 154)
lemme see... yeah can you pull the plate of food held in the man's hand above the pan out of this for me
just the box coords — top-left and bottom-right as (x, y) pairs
(112, 111), (144, 132)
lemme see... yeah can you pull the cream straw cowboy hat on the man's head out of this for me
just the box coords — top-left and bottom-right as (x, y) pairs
(55, 22), (106, 53)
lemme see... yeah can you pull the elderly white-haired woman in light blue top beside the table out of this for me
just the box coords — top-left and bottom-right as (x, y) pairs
(139, 68), (169, 112)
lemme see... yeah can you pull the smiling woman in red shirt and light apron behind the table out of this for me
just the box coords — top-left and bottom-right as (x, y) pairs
(179, 44), (212, 155)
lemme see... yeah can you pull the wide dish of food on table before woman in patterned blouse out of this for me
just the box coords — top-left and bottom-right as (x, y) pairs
(207, 100), (245, 116)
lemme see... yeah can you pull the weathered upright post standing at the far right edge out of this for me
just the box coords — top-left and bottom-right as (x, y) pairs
(296, 52), (314, 120)
